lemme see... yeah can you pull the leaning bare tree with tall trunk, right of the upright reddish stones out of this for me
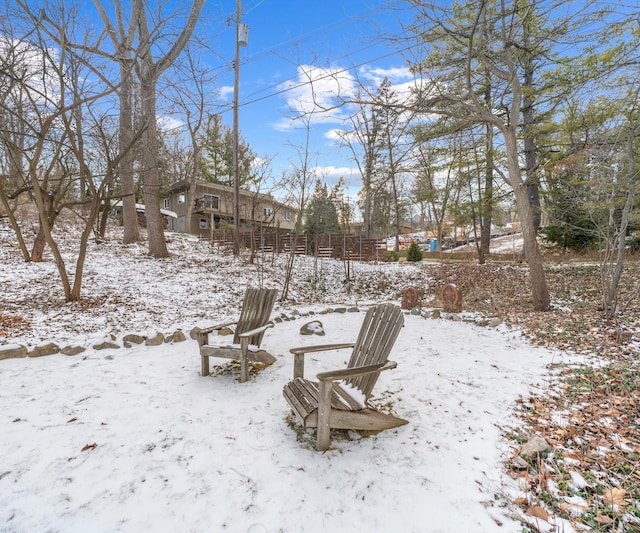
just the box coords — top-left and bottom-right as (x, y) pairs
(415, 0), (550, 311)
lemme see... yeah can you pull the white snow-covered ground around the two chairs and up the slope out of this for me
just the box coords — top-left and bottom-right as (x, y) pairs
(0, 225), (573, 533)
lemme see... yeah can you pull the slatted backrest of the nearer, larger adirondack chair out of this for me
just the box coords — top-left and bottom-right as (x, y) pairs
(347, 304), (404, 399)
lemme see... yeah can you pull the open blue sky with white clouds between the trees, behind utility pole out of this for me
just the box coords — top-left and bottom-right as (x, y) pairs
(201, 0), (416, 193)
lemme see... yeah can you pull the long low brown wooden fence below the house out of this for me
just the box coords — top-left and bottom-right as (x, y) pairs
(200, 231), (387, 261)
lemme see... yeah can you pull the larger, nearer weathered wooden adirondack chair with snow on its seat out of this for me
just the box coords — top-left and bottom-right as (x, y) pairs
(283, 304), (408, 451)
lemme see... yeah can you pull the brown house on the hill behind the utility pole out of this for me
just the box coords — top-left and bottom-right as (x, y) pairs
(163, 180), (297, 235)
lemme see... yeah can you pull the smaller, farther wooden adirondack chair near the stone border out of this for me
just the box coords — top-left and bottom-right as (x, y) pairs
(195, 289), (277, 382)
